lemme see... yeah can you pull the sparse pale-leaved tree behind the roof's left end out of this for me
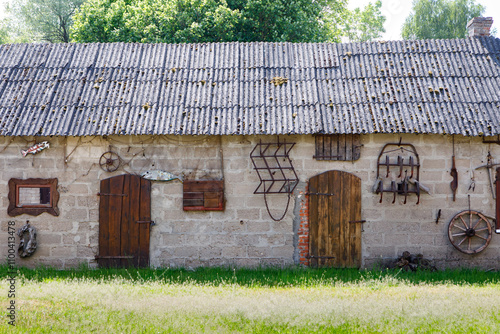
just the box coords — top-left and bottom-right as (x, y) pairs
(6, 0), (83, 43)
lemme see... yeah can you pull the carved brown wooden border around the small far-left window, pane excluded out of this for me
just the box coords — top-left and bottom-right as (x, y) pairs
(7, 178), (59, 217)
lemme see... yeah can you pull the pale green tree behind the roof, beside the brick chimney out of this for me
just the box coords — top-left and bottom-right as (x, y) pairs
(401, 0), (484, 39)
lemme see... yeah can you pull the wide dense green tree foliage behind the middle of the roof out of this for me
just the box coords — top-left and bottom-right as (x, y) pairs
(71, 0), (354, 43)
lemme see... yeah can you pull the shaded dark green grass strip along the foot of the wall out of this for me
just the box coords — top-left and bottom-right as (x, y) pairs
(0, 264), (500, 287)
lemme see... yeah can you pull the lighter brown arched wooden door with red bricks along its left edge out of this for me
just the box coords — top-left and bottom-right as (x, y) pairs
(309, 170), (361, 268)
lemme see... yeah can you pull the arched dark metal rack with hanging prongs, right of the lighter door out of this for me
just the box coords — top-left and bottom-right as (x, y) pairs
(373, 140), (429, 204)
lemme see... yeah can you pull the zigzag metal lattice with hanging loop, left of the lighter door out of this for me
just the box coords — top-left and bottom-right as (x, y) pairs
(250, 137), (299, 221)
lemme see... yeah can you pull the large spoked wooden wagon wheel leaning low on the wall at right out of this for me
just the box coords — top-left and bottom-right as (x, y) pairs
(448, 210), (491, 254)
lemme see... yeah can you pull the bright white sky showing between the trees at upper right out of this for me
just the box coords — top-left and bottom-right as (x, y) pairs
(348, 0), (500, 41)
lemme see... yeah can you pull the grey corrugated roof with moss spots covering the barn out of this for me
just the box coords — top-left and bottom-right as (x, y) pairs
(0, 37), (500, 136)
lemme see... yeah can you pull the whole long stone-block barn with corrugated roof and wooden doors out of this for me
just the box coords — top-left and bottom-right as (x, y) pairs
(0, 20), (500, 269)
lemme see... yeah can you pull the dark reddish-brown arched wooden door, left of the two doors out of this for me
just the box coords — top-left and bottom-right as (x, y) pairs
(96, 175), (151, 267)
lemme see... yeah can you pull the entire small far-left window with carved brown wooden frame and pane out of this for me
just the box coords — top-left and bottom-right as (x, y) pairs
(7, 179), (59, 217)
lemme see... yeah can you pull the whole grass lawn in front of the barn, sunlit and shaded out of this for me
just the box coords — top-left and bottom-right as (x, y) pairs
(0, 266), (500, 333)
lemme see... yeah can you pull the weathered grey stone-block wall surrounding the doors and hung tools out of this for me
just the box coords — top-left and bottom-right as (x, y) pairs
(0, 135), (500, 268)
